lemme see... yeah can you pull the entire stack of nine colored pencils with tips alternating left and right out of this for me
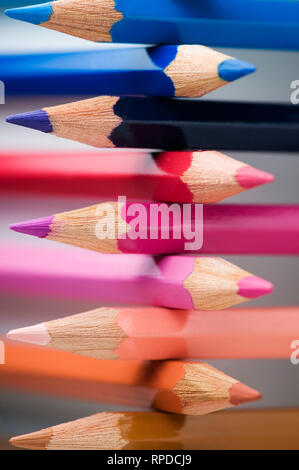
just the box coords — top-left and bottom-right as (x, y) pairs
(0, 0), (299, 450)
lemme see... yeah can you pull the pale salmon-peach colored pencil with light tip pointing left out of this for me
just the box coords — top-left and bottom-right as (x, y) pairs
(8, 307), (299, 360)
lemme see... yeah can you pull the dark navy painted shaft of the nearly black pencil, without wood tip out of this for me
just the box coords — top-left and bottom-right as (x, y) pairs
(109, 98), (299, 151)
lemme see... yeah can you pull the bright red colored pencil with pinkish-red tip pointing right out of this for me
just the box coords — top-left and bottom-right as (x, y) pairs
(0, 151), (274, 203)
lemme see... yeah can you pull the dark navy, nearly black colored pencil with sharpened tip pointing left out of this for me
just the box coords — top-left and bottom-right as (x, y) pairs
(7, 96), (299, 151)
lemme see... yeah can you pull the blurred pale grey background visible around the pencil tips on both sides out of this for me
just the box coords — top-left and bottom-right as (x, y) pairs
(0, 0), (299, 449)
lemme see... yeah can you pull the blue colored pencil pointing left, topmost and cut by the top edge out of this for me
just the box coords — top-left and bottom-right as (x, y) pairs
(6, 0), (299, 49)
